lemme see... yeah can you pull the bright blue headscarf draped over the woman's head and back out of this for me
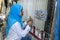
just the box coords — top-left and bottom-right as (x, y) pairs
(6, 4), (23, 37)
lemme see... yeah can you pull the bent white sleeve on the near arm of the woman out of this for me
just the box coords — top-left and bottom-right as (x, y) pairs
(12, 22), (31, 37)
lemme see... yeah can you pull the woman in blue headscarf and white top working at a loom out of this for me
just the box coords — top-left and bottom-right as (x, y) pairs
(6, 4), (32, 40)
